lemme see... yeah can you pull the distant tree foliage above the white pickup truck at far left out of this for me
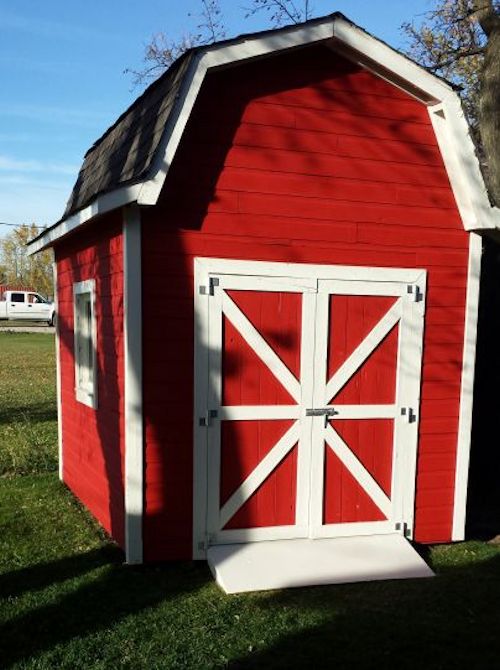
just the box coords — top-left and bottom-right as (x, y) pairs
(0, 224), (54, 295)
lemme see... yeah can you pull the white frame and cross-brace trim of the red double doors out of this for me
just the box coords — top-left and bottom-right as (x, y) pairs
(193, 258), (426, 558)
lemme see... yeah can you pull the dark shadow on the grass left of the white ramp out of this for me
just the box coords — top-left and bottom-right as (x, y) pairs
(0, 546), (210, 669)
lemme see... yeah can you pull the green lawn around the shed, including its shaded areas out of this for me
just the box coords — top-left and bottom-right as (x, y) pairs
(0, 335), (500, 670)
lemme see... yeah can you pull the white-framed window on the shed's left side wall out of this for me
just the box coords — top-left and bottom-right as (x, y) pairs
(73, 279), (97, 409)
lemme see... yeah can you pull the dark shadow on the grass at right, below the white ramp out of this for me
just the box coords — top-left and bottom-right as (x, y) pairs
(228, 556), (500, 670)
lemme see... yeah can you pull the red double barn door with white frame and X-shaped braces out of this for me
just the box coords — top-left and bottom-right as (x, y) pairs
(194, 259), (425, 555)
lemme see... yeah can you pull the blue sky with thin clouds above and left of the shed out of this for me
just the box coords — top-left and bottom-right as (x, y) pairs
(0, 0), (432, 237)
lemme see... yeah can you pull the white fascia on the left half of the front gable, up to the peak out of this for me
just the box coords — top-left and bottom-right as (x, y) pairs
(137, 18), (333, 205)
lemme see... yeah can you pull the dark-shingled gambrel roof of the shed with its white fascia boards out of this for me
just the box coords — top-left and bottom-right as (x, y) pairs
(30, 13), (500, 253)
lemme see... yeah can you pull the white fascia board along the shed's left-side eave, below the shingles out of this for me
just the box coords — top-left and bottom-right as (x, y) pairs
(28, 184), (141, 256)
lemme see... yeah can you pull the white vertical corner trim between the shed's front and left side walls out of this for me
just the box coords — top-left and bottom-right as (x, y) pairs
(123, 205), (144, 563)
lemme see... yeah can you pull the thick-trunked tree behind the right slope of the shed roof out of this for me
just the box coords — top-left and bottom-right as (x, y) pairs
(402, 0), (500, 205)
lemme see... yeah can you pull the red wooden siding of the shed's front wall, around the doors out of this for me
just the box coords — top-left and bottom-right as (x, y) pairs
(143, 47), (468, 560)
